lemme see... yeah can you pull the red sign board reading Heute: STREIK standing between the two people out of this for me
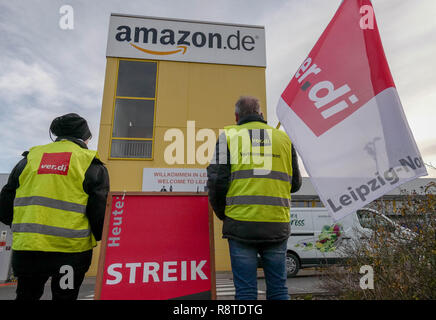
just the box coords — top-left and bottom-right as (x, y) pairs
(96, 194), (212, 300)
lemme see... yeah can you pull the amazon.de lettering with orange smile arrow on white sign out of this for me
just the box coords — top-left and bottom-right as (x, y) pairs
(115, 25), (257, 56)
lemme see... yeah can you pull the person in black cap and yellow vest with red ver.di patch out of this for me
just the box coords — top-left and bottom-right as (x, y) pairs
(0, 113), (109, 300)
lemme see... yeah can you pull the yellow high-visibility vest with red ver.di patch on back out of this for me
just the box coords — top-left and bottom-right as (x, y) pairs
(12, 140), (98, 252)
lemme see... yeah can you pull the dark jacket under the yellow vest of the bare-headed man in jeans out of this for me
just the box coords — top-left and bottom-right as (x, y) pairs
(207, 115), (302, 243)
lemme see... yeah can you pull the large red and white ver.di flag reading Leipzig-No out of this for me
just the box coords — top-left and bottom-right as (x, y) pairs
(277, 0), (427, 220)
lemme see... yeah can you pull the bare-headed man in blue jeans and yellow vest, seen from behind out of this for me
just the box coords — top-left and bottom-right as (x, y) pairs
(207, 97), (301, 300)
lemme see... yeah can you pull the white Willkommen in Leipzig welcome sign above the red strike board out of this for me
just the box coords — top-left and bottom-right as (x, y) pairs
(142, 168), (207, 192)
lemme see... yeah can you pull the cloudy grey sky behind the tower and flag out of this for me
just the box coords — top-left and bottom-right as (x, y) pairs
(0, 0), (436, 177)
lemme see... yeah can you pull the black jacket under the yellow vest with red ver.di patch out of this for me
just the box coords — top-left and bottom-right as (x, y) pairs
(0, 137), (109, 276)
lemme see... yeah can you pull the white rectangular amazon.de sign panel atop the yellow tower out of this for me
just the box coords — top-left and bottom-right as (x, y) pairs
(106, 14), (266, 67)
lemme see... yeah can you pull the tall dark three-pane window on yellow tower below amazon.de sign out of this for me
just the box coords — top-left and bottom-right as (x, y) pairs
(110, 59), (158, 160)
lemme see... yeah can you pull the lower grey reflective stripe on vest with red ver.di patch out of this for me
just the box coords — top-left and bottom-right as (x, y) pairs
(12, 223), (91, 238)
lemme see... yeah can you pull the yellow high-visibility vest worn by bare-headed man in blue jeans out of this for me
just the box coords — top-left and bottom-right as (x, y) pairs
(224, 122), (292, 222)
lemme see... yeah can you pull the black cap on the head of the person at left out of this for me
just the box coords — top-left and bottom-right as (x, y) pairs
(50, 113), (91, 141)
